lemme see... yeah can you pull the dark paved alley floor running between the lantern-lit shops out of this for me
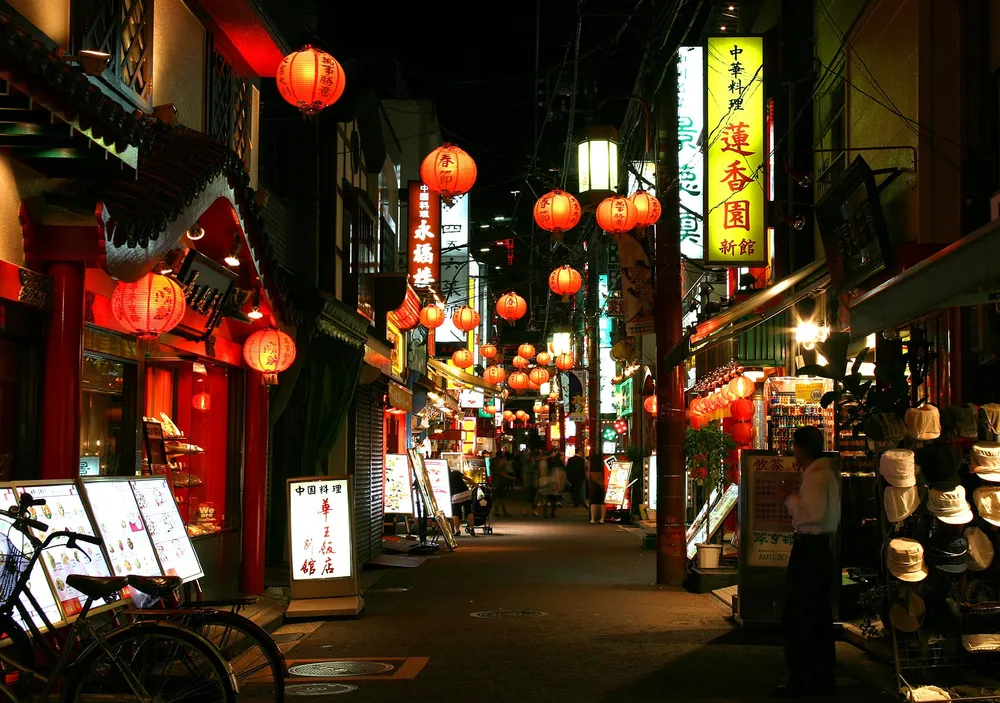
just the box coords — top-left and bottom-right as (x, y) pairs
(282, 498), (891, 703)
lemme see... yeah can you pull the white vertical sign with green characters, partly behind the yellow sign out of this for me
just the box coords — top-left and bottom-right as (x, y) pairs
(677, 46), (705, 259)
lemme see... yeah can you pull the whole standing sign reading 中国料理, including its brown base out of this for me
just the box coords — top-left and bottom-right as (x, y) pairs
(286, 476), (365, 618)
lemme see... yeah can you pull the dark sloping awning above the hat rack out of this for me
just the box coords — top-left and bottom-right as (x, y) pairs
(851, 220), (1000, 339)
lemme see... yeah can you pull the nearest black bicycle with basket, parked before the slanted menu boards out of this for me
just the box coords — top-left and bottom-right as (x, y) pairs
(0, 493), (238, 703)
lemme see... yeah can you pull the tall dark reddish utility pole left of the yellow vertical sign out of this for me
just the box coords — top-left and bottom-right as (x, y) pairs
(656, 58), (687, 585)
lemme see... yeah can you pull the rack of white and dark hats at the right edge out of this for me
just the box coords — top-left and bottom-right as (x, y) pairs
(873, 404), (1000, 701)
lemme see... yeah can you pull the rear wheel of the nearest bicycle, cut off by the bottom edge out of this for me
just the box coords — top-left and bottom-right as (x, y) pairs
(63, 622), (237, 703)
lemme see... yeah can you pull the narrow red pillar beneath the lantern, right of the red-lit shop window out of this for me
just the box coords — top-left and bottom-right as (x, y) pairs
(240, 372), (268, 594)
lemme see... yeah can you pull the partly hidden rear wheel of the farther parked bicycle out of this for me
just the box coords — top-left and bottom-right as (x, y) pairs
(184, 610), (286, 703)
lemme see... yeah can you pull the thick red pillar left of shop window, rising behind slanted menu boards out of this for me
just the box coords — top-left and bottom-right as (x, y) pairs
(42, 261), (84, 479)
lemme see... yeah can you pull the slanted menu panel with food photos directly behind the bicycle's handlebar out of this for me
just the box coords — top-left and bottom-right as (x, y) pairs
(14, 482), (118, 618)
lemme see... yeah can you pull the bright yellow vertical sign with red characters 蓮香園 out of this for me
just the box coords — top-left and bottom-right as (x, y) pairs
(704, 36), (767, 266)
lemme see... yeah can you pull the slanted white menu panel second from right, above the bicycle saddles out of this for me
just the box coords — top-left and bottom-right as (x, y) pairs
(83, 481), (163, 576)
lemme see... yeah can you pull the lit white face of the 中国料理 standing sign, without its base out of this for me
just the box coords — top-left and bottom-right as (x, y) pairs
(288, 478), (353, 581)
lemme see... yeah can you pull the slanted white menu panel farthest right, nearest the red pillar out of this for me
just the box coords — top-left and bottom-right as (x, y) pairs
(129, 476), (205, 583)
